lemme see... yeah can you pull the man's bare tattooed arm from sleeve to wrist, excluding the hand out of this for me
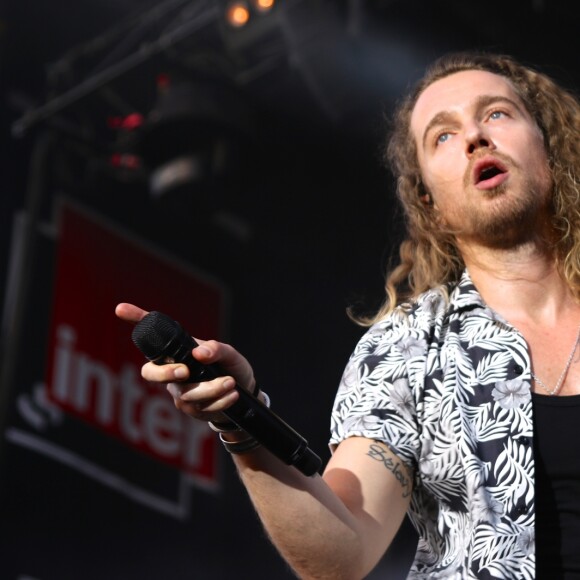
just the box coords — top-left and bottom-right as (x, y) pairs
(235, 437), (411, 580)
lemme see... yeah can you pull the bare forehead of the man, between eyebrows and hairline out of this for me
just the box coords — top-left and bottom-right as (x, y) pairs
(411, 70), (525, 139)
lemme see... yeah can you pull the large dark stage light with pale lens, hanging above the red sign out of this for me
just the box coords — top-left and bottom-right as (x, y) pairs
(131, 75), (253, 204)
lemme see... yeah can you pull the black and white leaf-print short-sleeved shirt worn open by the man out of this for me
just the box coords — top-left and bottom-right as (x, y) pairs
(330, 272), (535, 579)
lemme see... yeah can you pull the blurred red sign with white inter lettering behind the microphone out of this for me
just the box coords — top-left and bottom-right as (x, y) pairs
(46, 205), (225, 484)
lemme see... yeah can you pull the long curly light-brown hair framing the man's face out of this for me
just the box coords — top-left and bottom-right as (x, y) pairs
(355, 52), (580, 326)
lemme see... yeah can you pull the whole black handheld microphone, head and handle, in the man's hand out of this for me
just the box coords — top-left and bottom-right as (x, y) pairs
(132, 311), (322, 476)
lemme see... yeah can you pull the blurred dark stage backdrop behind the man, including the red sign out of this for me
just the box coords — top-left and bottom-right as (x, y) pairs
(0, 0), (580, 580)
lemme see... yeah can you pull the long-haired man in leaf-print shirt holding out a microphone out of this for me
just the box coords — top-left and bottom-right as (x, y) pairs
(117, 55), (580, 580)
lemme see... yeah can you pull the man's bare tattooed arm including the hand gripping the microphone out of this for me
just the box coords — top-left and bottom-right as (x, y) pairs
(117, 304), (411, 580)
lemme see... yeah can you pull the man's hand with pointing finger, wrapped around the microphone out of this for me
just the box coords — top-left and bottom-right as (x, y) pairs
(115, 303), (256, 422)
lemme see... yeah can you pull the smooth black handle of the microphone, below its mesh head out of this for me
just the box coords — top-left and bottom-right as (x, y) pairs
(150, 332), (322, 476)
